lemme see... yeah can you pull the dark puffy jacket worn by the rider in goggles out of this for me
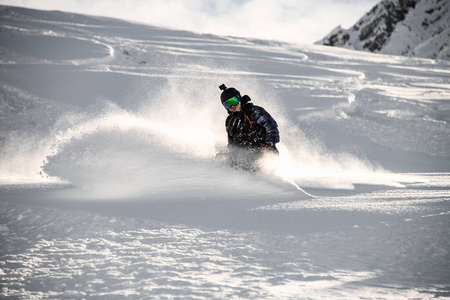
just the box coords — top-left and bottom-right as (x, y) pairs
(225, 102), (280, 149)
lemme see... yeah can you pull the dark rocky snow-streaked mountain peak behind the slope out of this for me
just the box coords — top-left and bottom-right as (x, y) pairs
(316, 0), (450, 59)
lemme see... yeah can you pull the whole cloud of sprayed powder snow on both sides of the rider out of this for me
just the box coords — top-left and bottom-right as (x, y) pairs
(36, 73), (414, 198)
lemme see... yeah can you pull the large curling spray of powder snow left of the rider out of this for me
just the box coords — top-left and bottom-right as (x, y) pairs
(39, 80), (282, 198)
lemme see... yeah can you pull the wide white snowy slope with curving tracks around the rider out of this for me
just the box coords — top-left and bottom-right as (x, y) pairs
(0, 6), (450, 299)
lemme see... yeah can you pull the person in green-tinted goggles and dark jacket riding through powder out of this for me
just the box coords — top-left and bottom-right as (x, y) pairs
(219, 84), (280, 168)
